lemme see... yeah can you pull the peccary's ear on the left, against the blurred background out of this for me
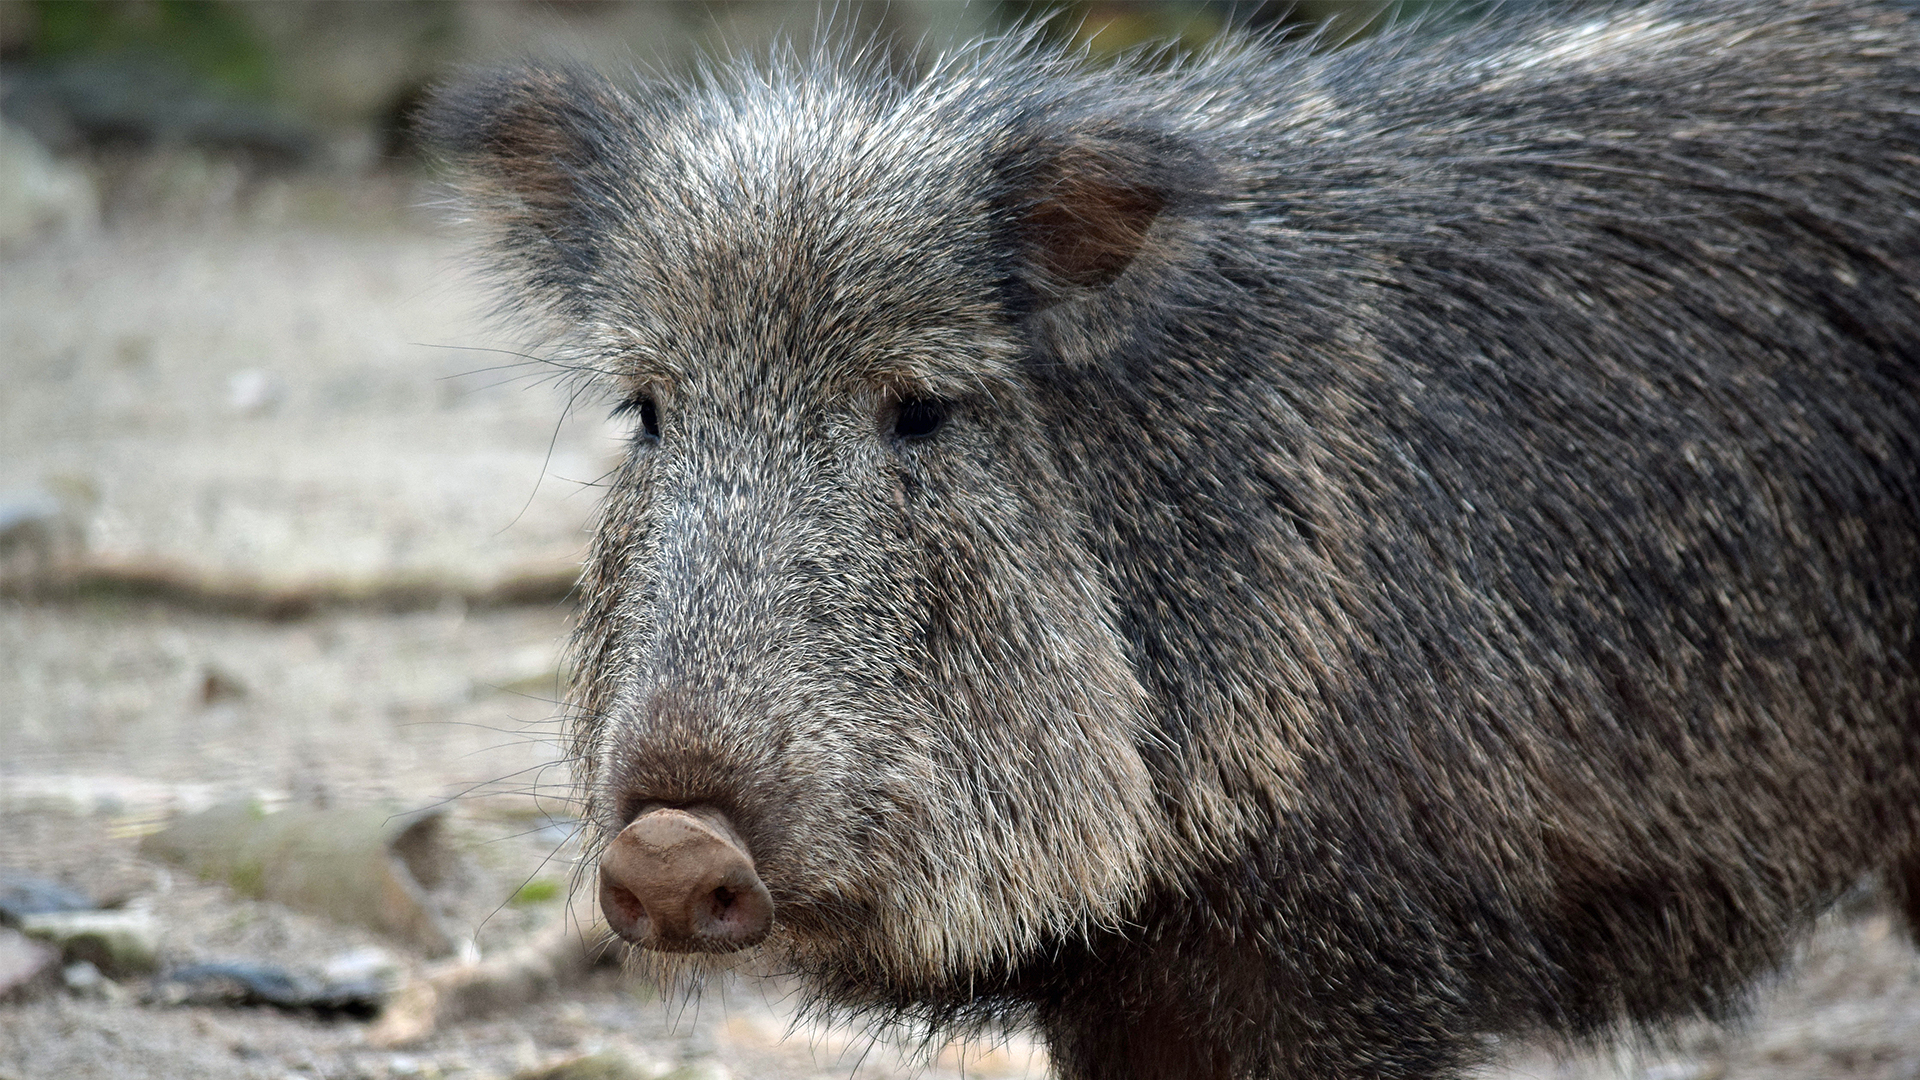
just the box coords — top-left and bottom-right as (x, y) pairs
(419, 67), (639, 297)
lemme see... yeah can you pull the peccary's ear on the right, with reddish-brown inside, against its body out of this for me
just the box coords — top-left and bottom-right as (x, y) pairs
(1000, 125), (1219, 307)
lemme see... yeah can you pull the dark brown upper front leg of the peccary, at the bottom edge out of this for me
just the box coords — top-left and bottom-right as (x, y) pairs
(1016, 883), (1478, 1080)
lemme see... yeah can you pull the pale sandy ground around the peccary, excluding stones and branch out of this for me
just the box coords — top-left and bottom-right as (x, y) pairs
(0, 160), (1920, 1080)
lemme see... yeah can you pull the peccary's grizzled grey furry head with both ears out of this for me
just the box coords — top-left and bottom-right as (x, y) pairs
(430, 61), (1217, 1001)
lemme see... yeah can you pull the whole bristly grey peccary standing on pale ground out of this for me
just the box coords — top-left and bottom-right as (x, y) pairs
(426, 2), (1920, 1078)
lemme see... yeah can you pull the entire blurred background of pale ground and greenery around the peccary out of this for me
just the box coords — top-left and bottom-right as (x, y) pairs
(0, 0), (1920, 1080)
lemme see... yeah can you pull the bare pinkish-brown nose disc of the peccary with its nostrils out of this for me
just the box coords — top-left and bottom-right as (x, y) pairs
(599, 807), (774, 953)
